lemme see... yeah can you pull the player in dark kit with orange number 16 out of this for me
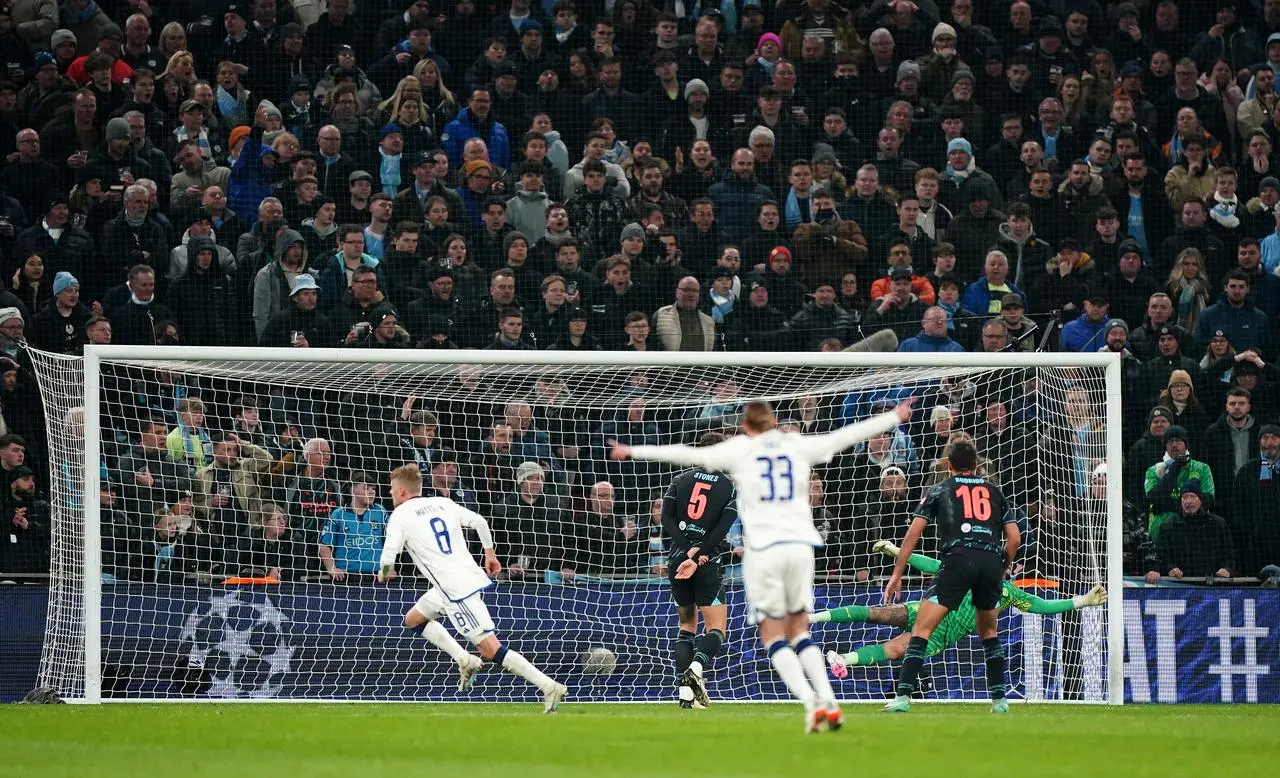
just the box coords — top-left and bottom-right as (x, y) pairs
(884, 441), (1021, 713)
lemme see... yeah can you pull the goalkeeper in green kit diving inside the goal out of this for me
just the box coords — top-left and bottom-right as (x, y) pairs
(813, 540), (1107, 678)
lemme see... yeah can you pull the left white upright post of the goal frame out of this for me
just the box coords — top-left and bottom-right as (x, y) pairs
(83, 349), (102, 704)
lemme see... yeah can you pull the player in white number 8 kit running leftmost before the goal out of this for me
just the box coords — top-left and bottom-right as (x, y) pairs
(378, 464), (568, 713)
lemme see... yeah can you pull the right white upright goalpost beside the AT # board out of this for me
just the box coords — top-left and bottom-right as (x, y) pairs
(1103, 356), (1124, 705)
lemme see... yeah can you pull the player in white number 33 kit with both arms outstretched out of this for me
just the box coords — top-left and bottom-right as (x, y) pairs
(609, 401), (914, 732)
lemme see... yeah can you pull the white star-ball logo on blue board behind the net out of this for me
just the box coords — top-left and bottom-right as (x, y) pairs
(179, 591), (297, 699)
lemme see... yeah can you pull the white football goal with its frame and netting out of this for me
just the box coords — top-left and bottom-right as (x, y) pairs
(31, 345), (1124, 704)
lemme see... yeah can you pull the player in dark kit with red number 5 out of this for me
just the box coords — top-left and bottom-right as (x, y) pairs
(662, 433), (737, 708)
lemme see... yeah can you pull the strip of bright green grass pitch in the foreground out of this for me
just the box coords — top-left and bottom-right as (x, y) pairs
(0, 703), (1280, 778)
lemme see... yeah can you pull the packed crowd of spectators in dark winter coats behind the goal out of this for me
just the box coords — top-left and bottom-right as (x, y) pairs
(0, 0), (1280, 581)
